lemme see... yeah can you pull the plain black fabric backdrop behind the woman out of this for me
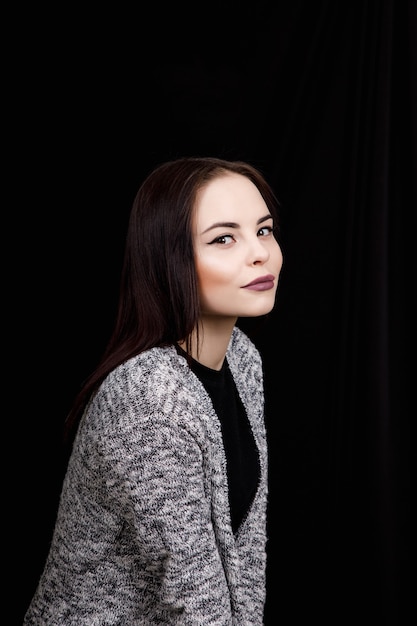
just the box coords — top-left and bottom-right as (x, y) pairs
(15, 0), (417, 626)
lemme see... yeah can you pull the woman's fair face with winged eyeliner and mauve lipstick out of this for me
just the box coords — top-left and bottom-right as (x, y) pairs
(194, 173), (282, 318)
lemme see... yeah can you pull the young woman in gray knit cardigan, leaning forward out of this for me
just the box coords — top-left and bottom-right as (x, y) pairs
(24, 158), (282, 626)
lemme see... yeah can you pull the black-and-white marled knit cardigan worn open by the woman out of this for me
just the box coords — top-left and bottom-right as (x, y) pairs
(24, 327), (267, 626)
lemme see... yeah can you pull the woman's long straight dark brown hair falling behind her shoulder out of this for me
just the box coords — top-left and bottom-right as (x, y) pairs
(65, 157), (278, 440)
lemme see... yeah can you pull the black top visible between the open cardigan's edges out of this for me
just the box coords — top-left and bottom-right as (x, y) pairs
(177, 347), (260, 533)
